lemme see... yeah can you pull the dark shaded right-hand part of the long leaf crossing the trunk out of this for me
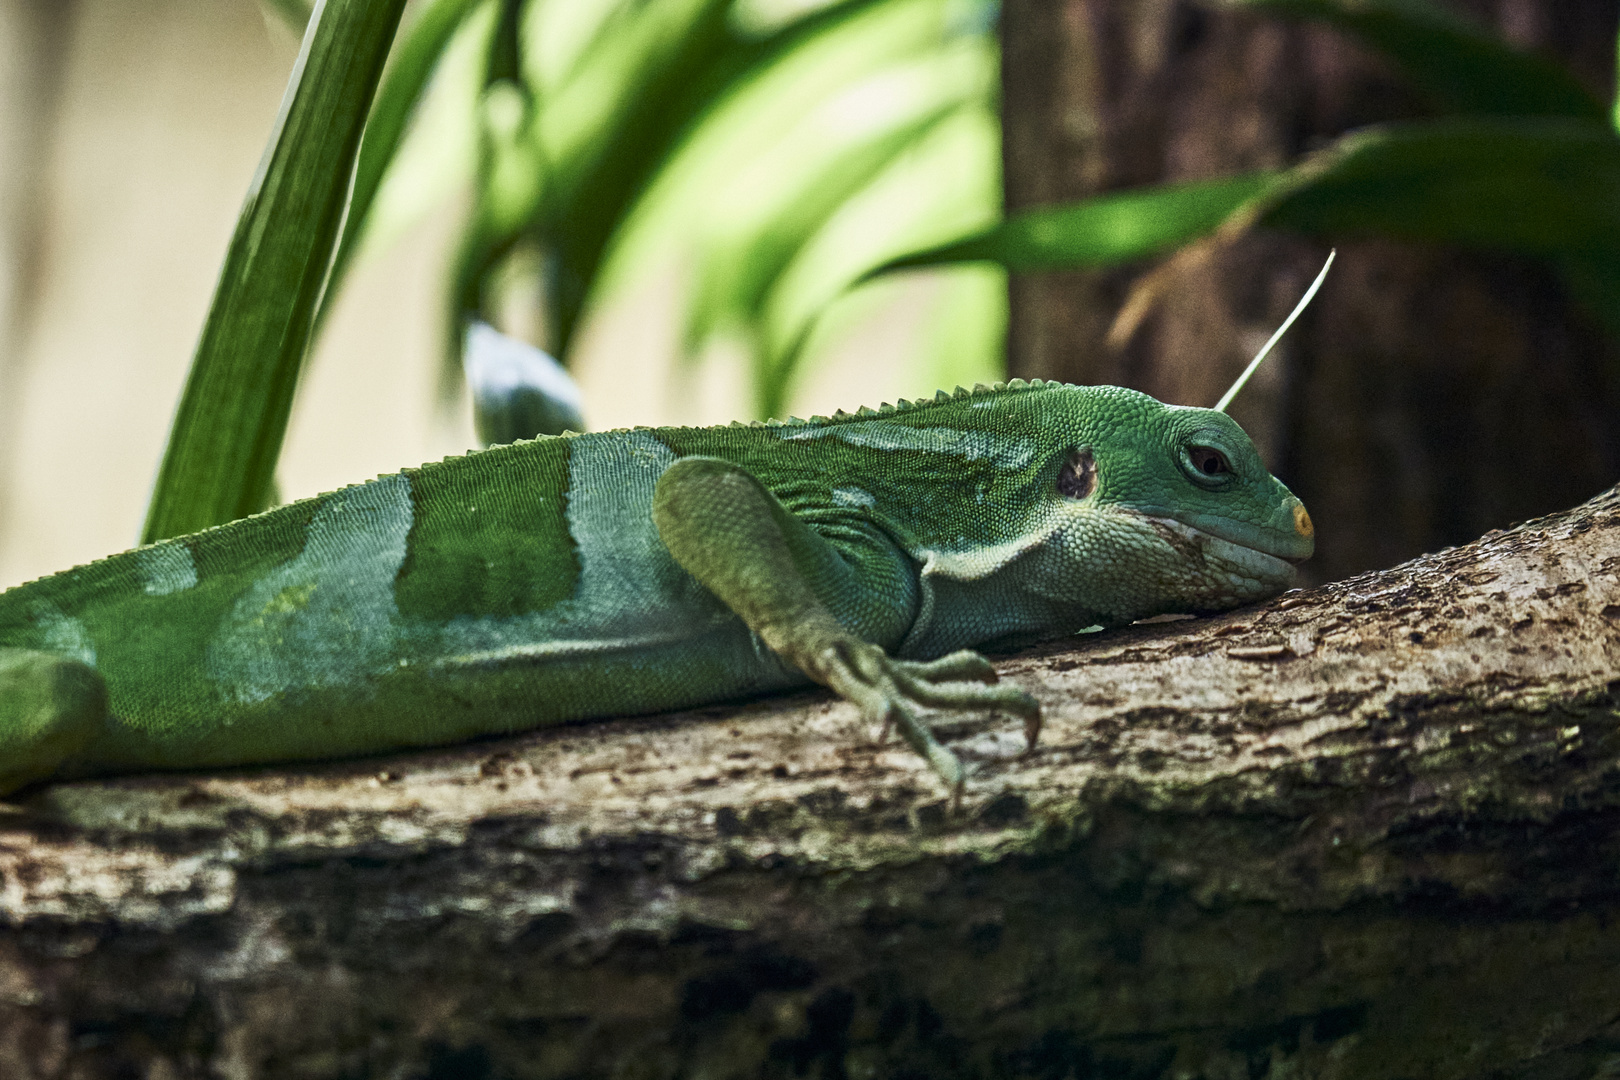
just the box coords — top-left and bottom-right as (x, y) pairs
(1252, 117), (1620, 257)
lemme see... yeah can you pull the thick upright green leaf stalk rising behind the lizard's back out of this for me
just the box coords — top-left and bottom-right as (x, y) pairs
(143, 0), (405, 542)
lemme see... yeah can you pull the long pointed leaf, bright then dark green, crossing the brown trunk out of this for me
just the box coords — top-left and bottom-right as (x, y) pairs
(868, 117), (1620, 277)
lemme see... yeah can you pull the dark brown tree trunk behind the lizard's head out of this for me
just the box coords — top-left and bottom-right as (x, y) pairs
(1003, 0), (1620, 581)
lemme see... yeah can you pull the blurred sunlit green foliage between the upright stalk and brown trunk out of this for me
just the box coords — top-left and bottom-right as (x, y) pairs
(327, 0), (1004, 416)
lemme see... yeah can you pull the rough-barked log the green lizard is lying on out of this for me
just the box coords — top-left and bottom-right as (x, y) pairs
(0, 489), (1620, 1080)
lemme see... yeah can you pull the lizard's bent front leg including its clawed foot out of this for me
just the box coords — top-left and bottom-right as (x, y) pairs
(653, 457), (1040, 795)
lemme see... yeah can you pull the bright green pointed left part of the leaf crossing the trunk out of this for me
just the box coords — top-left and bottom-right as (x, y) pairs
(862, 172), (1281, 280)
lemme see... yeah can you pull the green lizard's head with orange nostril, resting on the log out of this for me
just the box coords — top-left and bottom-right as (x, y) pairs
(1032, 387), (1315, 622)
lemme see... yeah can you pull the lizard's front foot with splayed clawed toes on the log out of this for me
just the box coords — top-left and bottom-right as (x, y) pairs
(818, 640), (1040, 805)
